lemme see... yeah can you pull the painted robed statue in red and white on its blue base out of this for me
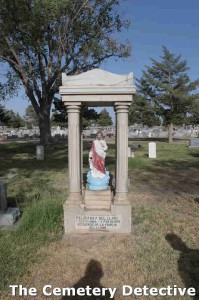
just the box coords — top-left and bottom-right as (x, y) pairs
(87, 130), (110, 190)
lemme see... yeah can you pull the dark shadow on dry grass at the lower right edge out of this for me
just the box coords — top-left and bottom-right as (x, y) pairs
(165, 233), (199, 300)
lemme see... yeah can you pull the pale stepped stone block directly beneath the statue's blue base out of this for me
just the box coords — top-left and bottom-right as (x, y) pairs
(84, 187), (113, 210)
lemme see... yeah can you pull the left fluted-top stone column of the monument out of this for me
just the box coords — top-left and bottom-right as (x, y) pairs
(66, 102), (82, 205)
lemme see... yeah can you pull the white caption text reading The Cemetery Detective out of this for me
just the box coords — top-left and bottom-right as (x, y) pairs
(9, 285), (196, 299)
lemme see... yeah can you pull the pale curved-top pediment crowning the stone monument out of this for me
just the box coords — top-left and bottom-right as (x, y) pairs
(62, 69), (133, 87)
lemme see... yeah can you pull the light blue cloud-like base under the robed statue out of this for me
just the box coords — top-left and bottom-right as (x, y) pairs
(87, 171), (110, 191)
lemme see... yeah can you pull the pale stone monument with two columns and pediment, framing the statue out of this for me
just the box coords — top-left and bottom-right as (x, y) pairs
(60, 69), (135, 234)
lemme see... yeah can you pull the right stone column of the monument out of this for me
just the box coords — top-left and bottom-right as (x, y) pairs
(114, 102), (129, 204)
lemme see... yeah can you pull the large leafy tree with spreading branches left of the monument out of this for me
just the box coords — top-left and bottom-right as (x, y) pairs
(0, 0), (130, 144)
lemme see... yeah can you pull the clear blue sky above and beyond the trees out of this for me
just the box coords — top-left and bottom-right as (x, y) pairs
(2, 0), (199, 115)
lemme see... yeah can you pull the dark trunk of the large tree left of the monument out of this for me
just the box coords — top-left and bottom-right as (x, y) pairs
(39, 107), (52, 145)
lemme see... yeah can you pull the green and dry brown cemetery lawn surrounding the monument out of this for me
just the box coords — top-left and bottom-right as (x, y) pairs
(0, 140), (199, 300)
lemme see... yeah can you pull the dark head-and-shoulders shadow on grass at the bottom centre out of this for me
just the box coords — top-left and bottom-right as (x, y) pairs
(61, 259), (114, 300)
